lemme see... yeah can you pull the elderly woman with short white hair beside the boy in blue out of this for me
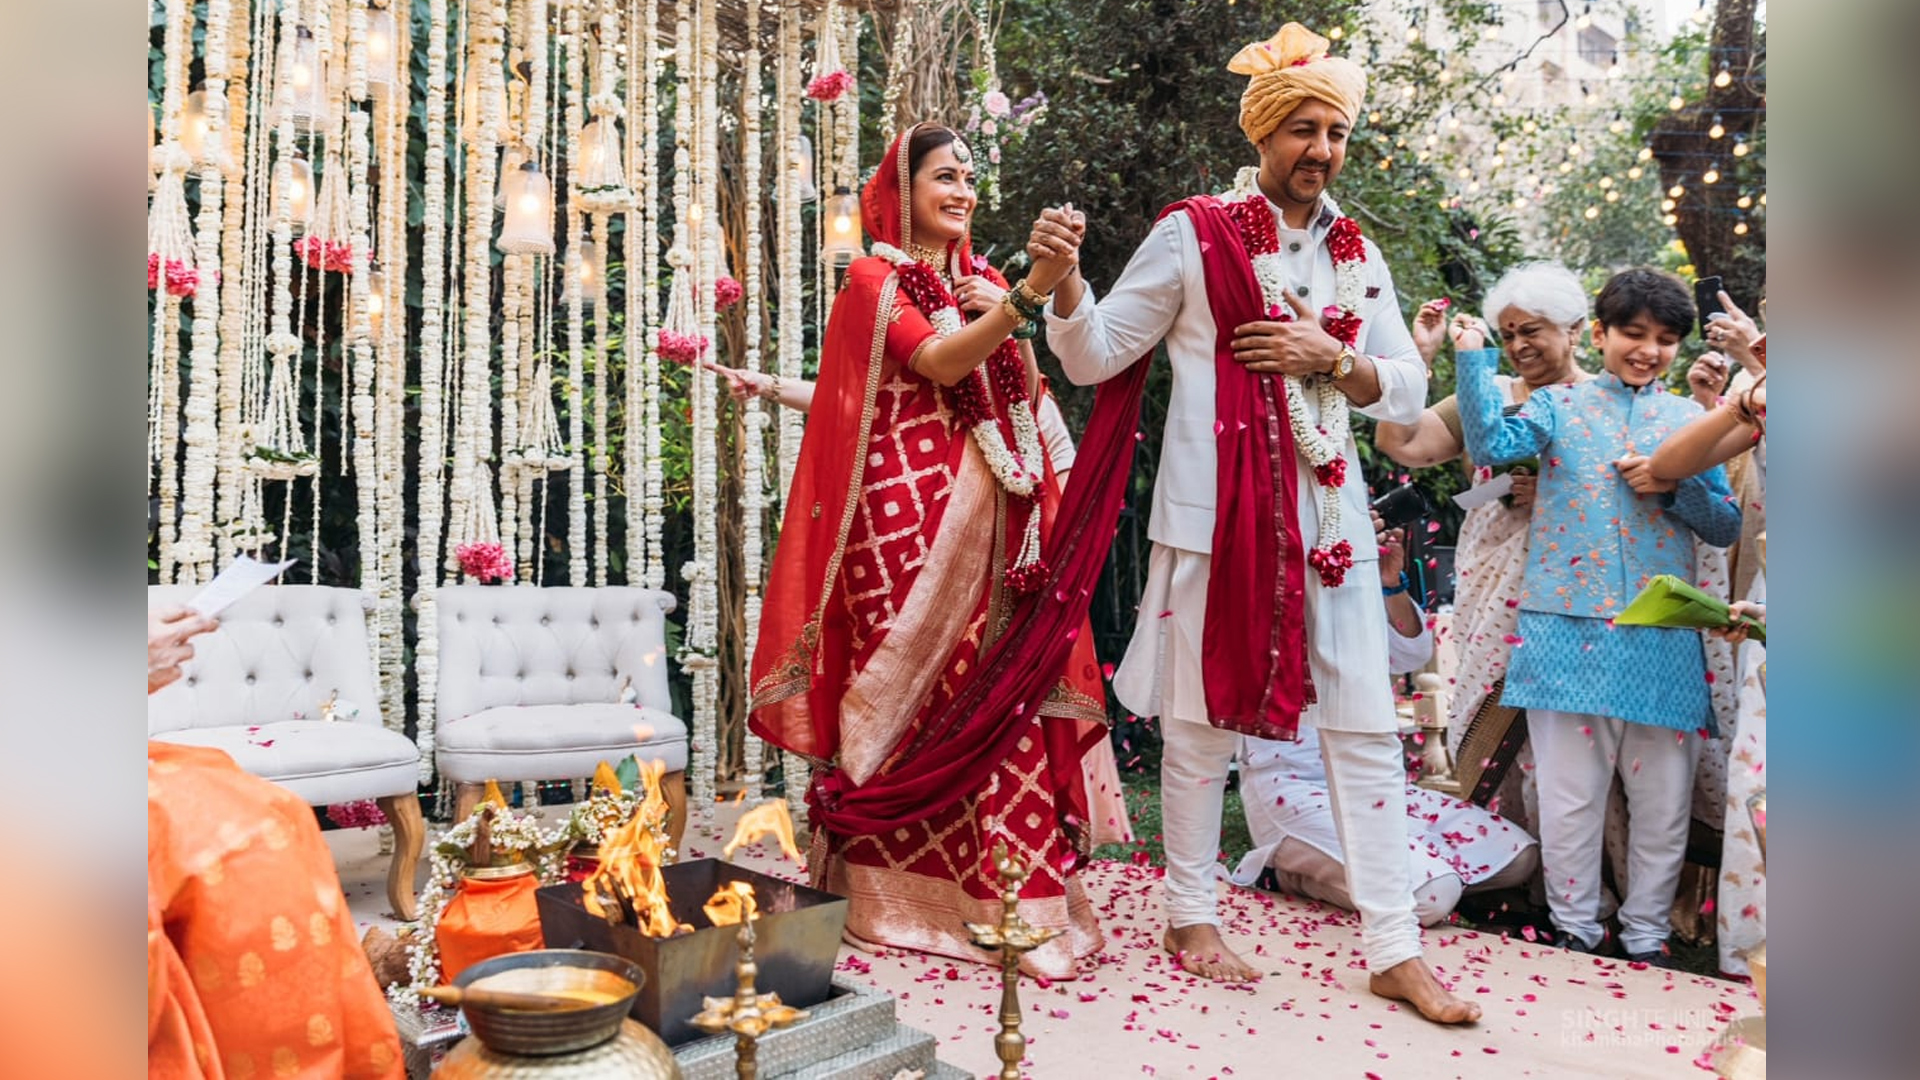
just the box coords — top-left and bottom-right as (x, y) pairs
(1375, 261), (1592, 830)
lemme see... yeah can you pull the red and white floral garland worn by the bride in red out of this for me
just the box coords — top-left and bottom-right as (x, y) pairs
(874, 244), (1046, 596)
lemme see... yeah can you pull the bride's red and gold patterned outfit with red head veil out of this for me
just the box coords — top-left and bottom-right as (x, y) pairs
(751, 129), (1110, 978)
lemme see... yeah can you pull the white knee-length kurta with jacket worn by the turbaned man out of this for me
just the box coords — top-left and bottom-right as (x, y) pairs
(1046, 198), (1427, 732)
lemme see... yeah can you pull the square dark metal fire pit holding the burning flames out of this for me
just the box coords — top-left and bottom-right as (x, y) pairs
(536, 859), (847, 1045)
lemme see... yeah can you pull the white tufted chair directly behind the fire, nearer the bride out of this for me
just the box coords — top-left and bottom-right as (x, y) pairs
(434, 584), (687, 847)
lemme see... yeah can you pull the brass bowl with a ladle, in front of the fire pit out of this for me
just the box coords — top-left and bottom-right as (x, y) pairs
(453, 949), (645, 1055)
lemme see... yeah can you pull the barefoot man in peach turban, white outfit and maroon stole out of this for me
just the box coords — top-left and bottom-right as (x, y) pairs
(1029, 23), (1480, 1022)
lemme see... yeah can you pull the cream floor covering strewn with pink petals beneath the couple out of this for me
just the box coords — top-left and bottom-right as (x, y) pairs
(326, 795), (1759, 1080)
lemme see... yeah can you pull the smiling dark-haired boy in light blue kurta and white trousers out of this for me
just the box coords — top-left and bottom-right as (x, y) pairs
(1453, 269), (1740, 967)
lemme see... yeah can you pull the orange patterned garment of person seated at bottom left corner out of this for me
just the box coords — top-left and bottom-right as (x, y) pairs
(146, 742), (405, 1080)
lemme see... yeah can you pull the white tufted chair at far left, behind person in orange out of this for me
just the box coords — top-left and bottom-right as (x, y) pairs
(146, 584), (426, 920)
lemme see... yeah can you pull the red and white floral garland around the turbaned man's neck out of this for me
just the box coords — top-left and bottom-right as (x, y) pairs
(1227, 192), (1367, 588)
